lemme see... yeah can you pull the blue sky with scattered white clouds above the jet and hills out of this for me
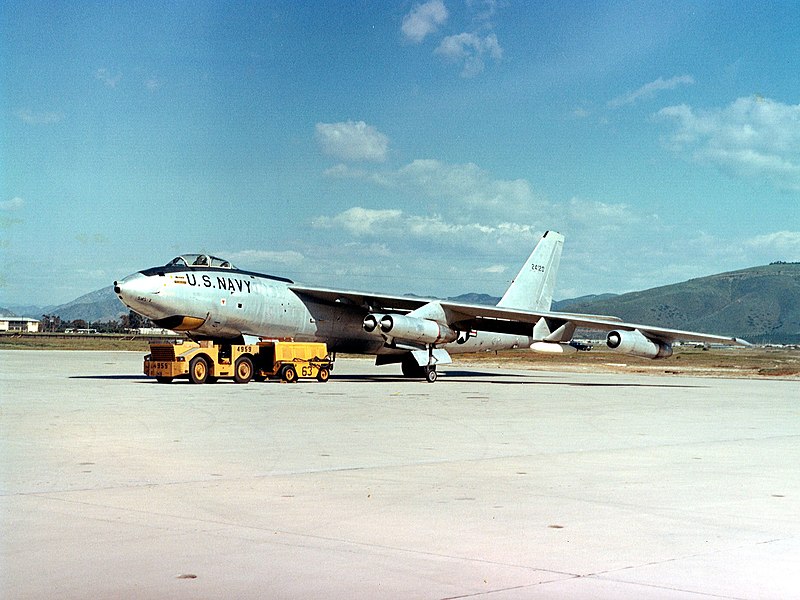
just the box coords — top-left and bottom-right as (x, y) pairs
(0, 0), (800, 306)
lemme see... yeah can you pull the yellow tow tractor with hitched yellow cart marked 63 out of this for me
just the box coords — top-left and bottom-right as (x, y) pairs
(144, 341), (333, 383)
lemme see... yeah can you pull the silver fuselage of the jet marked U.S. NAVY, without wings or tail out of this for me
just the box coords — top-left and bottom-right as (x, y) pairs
(114, 264), (533, 355)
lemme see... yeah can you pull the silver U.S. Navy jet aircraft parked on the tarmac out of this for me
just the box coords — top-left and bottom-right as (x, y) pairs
(114, 231), (747, 382)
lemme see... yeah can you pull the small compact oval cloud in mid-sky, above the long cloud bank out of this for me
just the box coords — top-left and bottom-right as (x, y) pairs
(316, 121), (389, 162)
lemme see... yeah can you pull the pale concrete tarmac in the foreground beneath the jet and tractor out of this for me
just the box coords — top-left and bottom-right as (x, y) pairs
(0, 351), (800, 600)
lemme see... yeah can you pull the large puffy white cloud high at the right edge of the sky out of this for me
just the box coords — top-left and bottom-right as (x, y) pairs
(658, 97), (800, 191)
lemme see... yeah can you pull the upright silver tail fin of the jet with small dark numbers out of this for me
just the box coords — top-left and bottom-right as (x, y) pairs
(497, 231), (564, 310)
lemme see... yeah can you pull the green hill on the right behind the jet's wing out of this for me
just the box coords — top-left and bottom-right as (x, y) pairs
(559, 263), (800, 343)
